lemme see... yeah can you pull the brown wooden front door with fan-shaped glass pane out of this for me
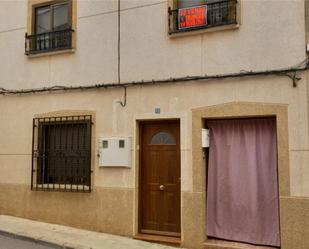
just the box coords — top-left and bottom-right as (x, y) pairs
(139, 121), (180, 236)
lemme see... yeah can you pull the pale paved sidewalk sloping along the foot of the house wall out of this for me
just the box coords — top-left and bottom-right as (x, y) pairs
(0, 215), (182, 249)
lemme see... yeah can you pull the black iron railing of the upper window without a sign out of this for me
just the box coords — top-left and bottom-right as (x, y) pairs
(25, 29), (74, 55)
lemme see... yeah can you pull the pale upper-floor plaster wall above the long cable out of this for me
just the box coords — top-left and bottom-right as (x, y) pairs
(0, 0), (305, 89)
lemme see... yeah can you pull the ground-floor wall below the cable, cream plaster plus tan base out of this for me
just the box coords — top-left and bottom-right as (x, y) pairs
(0, 74), (309, 249)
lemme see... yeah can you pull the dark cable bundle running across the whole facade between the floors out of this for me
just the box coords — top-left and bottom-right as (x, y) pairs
(0, 60), (309, 96)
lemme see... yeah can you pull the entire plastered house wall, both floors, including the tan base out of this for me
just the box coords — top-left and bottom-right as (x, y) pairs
(0, 0), (309, 249)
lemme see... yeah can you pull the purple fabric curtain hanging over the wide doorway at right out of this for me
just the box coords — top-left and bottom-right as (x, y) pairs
(207, 118), (280, 247)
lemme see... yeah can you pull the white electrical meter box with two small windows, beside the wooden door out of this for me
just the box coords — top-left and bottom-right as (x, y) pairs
(99, 137), (132, 168)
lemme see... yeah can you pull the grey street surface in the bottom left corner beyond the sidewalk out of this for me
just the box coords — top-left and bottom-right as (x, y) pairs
(0, 234), (55, 249)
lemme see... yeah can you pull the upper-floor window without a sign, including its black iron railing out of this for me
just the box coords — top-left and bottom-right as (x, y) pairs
(26, 1), (73, 55)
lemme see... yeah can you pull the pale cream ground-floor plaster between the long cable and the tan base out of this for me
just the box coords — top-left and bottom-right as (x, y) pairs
(0, 75), (309, 196)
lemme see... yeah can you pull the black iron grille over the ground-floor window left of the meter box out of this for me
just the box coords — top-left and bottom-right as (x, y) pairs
(31, 115), (92, 192)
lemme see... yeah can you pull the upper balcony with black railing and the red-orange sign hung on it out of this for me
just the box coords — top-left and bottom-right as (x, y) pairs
(168, 0), (237, 35)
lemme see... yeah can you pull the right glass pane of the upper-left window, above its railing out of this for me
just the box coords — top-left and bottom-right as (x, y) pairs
(53, 3), (69, 31)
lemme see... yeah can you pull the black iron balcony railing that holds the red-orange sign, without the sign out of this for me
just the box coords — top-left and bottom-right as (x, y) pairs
(168, 0), (237, 34)
